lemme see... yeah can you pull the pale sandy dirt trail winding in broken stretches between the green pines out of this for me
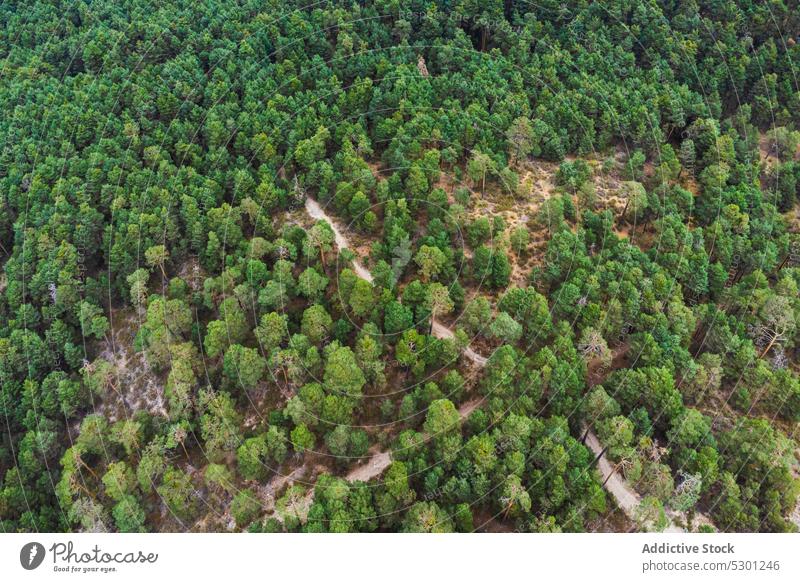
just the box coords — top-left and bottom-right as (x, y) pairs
(306, 197), (713, 533)
